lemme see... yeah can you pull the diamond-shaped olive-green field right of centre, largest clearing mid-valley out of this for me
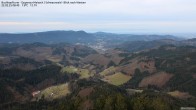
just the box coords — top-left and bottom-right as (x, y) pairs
(103, 72), (131, 86)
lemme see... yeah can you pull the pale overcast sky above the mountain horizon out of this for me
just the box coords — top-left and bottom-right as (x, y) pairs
(0, 0), (196, 34)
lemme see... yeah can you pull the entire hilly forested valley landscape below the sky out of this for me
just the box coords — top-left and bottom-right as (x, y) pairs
(0, 31), (196, 110)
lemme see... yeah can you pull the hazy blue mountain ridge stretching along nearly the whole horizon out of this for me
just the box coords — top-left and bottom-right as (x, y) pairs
(0, 31), (182, 44)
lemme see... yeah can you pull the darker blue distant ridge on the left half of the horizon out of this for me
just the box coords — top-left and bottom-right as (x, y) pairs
(0, 31), (93, 43)
